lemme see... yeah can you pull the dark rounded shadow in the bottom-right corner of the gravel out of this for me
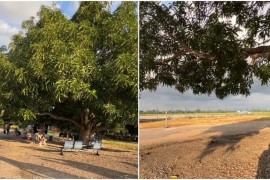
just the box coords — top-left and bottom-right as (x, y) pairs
(256, 144), (270, 179)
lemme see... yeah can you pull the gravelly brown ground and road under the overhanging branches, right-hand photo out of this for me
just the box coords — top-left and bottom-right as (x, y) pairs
(140, 118), (270, 179)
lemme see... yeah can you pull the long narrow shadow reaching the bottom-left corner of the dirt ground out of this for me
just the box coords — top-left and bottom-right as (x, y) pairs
(0, 157), (83, 179)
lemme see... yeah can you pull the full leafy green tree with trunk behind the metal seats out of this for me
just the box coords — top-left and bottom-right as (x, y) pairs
(0, 2), (138, 142)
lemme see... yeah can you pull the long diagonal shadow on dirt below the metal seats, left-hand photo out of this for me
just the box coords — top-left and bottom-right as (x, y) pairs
(34, 156), (138, 179)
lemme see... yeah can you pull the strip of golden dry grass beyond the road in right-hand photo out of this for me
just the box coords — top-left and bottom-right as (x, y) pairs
(140, 115), (269, 129)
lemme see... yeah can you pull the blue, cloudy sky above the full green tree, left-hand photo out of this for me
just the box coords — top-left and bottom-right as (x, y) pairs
(0, 1), (121, 46)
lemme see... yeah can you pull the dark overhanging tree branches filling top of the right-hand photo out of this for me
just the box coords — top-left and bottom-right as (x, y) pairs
(140, 1), (270, 98)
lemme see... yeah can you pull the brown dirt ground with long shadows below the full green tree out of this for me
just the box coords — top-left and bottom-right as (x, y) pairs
(0, 130), (138, 179)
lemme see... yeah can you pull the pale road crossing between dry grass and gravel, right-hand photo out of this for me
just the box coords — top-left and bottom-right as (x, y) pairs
(140, 119), (270, 146)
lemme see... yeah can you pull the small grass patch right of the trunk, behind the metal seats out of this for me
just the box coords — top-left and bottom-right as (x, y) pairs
(102, 139), (138, 151)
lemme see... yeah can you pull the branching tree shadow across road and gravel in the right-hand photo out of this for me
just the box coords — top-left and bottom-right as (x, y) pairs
(198, 118), (270, 161)
